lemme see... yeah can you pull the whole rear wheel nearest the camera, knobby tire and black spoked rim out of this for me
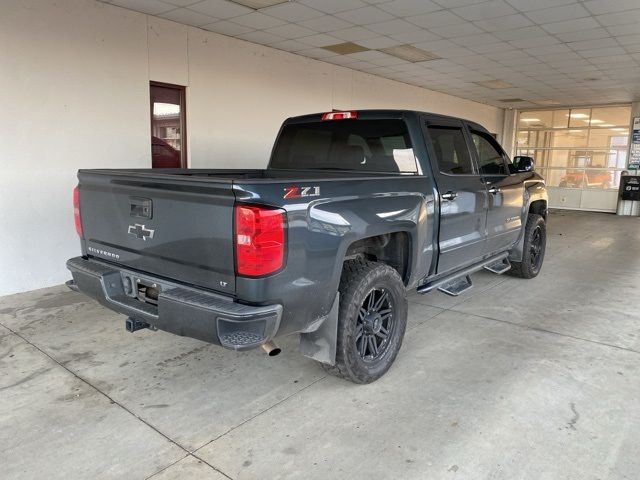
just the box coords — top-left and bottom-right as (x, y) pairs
(324, 260), (407, 383)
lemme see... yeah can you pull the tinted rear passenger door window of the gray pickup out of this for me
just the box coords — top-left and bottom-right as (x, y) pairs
(428, 126), (474, 175)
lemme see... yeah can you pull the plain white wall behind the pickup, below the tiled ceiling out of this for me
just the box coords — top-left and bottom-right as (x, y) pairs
(0, 0), (504, 295)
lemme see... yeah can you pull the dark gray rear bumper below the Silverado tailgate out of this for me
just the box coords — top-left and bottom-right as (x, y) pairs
(67, 257), (282, 350)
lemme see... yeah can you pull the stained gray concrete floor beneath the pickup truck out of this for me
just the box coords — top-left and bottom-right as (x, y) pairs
(0, 212), (640, 480)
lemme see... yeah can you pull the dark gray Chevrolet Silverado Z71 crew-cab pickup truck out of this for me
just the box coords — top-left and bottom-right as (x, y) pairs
(67, 110), (547, 383)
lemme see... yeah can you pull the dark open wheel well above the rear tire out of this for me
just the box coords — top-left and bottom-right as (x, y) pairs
(345, 232), (409, 285)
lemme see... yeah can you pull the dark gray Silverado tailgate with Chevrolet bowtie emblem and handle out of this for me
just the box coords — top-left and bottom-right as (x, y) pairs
(78, 170), (235, 294)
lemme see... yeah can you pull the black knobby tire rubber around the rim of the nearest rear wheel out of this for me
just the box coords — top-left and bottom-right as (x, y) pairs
(323, 260), (407, 383)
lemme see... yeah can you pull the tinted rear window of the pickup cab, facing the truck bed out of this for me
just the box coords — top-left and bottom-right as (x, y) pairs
(270, 120), (418, 174)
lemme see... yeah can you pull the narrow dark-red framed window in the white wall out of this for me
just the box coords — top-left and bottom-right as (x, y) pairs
(150, 83), (186, 168)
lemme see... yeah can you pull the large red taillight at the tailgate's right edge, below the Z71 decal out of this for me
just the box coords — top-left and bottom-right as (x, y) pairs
(234, 205), (285, 277)
